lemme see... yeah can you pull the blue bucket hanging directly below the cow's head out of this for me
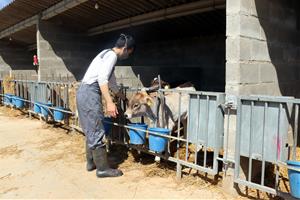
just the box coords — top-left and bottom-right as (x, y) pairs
(128, 123), (148, 144)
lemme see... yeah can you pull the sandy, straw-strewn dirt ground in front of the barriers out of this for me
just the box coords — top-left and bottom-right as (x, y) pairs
(0, 107), (241, 199)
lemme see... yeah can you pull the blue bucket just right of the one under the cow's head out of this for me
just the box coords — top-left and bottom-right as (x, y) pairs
(149, 128), (170, 153)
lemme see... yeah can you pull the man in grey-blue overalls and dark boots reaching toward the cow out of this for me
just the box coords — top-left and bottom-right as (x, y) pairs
(76, 34), (135, 178)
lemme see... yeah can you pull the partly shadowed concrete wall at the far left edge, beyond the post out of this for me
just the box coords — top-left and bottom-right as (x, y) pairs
(0, 42), (37, 80)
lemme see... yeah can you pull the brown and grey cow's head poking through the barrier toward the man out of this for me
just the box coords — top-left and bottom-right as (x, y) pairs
(125, 92), (155, 119)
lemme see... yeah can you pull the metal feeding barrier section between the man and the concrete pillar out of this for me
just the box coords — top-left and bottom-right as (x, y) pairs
(103, 85), (225, 177)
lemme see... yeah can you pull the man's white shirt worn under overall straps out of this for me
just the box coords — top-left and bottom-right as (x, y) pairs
(82, 49), (119, 92)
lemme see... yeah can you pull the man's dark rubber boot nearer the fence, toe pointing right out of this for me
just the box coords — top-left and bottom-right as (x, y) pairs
(92, 147), (123, 178)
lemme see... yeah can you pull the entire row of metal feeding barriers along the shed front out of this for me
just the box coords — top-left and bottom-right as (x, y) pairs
(0, 77), (300, 194)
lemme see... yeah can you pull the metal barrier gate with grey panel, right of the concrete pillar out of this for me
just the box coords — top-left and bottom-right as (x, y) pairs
(234, 96), (300, 194)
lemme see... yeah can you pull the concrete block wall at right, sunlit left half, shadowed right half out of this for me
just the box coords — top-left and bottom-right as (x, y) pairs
(226, 0), (300, 97)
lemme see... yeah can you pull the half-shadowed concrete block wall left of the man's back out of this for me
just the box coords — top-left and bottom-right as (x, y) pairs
(37, 21), (97, 80)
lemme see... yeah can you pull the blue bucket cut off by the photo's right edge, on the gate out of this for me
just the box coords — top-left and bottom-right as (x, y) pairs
(287, 160), (300, 198)
